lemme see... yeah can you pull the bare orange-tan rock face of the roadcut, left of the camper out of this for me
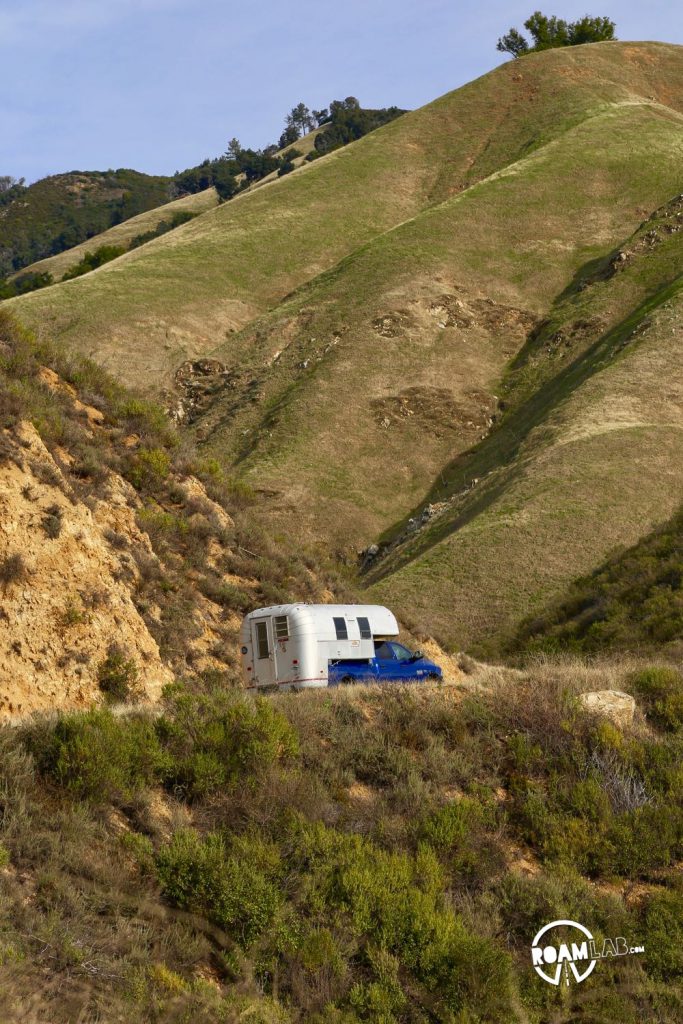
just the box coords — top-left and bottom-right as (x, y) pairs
(0, 423), (172, 717)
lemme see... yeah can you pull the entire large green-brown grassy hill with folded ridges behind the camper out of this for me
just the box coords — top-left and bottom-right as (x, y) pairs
(10, 42), (683, 650)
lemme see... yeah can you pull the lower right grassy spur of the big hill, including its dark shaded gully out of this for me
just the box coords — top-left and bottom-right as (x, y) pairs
(370, 195), (683, 651)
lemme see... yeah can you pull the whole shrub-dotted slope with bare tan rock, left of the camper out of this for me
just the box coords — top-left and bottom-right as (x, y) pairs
(0, 312), (362, 720)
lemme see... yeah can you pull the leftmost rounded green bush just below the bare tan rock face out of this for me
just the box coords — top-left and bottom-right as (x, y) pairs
(23, 709), (165, 804)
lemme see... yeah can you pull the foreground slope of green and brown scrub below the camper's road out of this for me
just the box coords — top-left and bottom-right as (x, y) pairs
(0, 665), (683, 1024)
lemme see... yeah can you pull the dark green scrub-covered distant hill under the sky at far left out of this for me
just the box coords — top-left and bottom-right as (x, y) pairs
(0, 170), (171, 276)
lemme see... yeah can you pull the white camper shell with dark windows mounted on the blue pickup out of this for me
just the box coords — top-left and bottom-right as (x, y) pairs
(240, 604), (398, 689)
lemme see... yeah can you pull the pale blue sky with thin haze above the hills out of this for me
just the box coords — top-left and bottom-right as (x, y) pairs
(0, 0), (683, 181)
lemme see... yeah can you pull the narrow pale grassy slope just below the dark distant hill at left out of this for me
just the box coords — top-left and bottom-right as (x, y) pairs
(11, 188), (217, 282)
